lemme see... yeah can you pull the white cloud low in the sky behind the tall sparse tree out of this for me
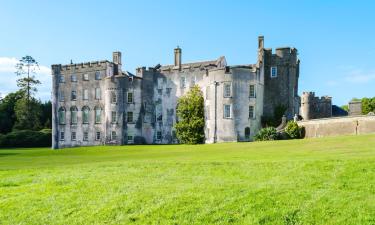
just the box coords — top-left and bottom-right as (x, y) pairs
(0, 57), (52, 101)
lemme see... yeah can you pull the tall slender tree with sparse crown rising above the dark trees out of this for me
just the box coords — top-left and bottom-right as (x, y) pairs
(16, 55), (40, 128)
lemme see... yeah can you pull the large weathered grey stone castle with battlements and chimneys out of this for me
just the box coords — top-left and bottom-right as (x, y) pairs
(52, 36), (300, 148)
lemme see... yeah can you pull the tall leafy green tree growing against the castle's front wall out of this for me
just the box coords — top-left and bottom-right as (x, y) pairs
(175, 85), (205, 144)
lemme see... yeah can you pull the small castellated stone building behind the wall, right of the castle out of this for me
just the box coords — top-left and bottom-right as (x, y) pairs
(300, 92), (332, 120)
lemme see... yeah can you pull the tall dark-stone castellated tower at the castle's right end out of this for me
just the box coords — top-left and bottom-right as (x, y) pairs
(258, 40), (300, 119)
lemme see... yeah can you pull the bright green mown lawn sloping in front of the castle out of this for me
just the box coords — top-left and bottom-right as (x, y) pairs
(0, 135), (375, 224)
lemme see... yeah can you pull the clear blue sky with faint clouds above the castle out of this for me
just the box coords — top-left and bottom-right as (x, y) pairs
(0, 0), (375, 105)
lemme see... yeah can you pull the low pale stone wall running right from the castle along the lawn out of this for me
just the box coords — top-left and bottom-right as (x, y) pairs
(298, 116), (375, 138)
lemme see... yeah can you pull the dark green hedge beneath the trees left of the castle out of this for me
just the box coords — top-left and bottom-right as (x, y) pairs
(0, 129), (52, 148)
